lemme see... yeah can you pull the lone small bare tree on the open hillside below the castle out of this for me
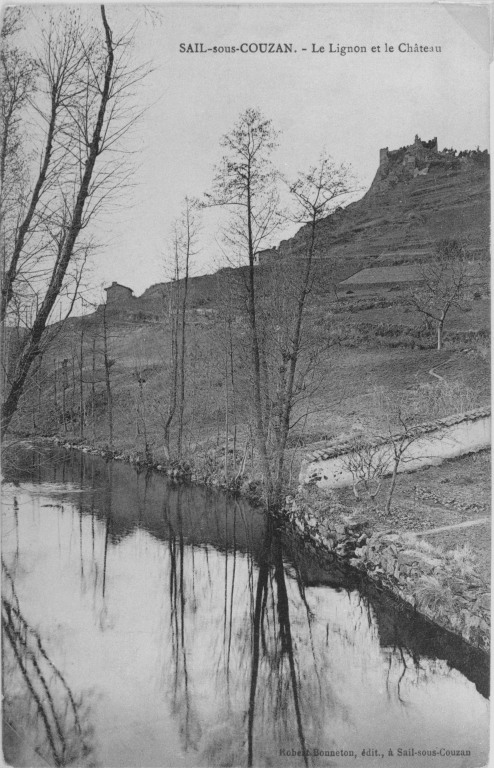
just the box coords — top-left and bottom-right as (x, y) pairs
(410, 240), (469, 350)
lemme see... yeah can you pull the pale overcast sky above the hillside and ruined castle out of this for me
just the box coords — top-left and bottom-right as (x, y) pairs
(21, 4), (489, 295)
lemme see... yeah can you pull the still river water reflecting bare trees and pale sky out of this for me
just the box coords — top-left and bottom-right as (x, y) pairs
(2, 449), (489, 768)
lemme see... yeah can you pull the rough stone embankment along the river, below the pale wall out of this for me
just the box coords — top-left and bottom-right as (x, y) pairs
(284, 496), (491, 651)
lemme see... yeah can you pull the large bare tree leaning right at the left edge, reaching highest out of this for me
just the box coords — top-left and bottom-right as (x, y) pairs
(2, 6), (149, 432)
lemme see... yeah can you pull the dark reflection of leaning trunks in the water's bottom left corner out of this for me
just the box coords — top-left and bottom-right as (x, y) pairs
(2, 559), (95, 766)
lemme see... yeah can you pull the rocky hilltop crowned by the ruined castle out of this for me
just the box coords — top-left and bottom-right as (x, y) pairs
(259, 136), (490, 276)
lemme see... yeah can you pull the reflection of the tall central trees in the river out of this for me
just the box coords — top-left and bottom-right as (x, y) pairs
(163, 489), (343, 766)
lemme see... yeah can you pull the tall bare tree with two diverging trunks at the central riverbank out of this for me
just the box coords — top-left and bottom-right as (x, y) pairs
(207, 120), (352, 507)
